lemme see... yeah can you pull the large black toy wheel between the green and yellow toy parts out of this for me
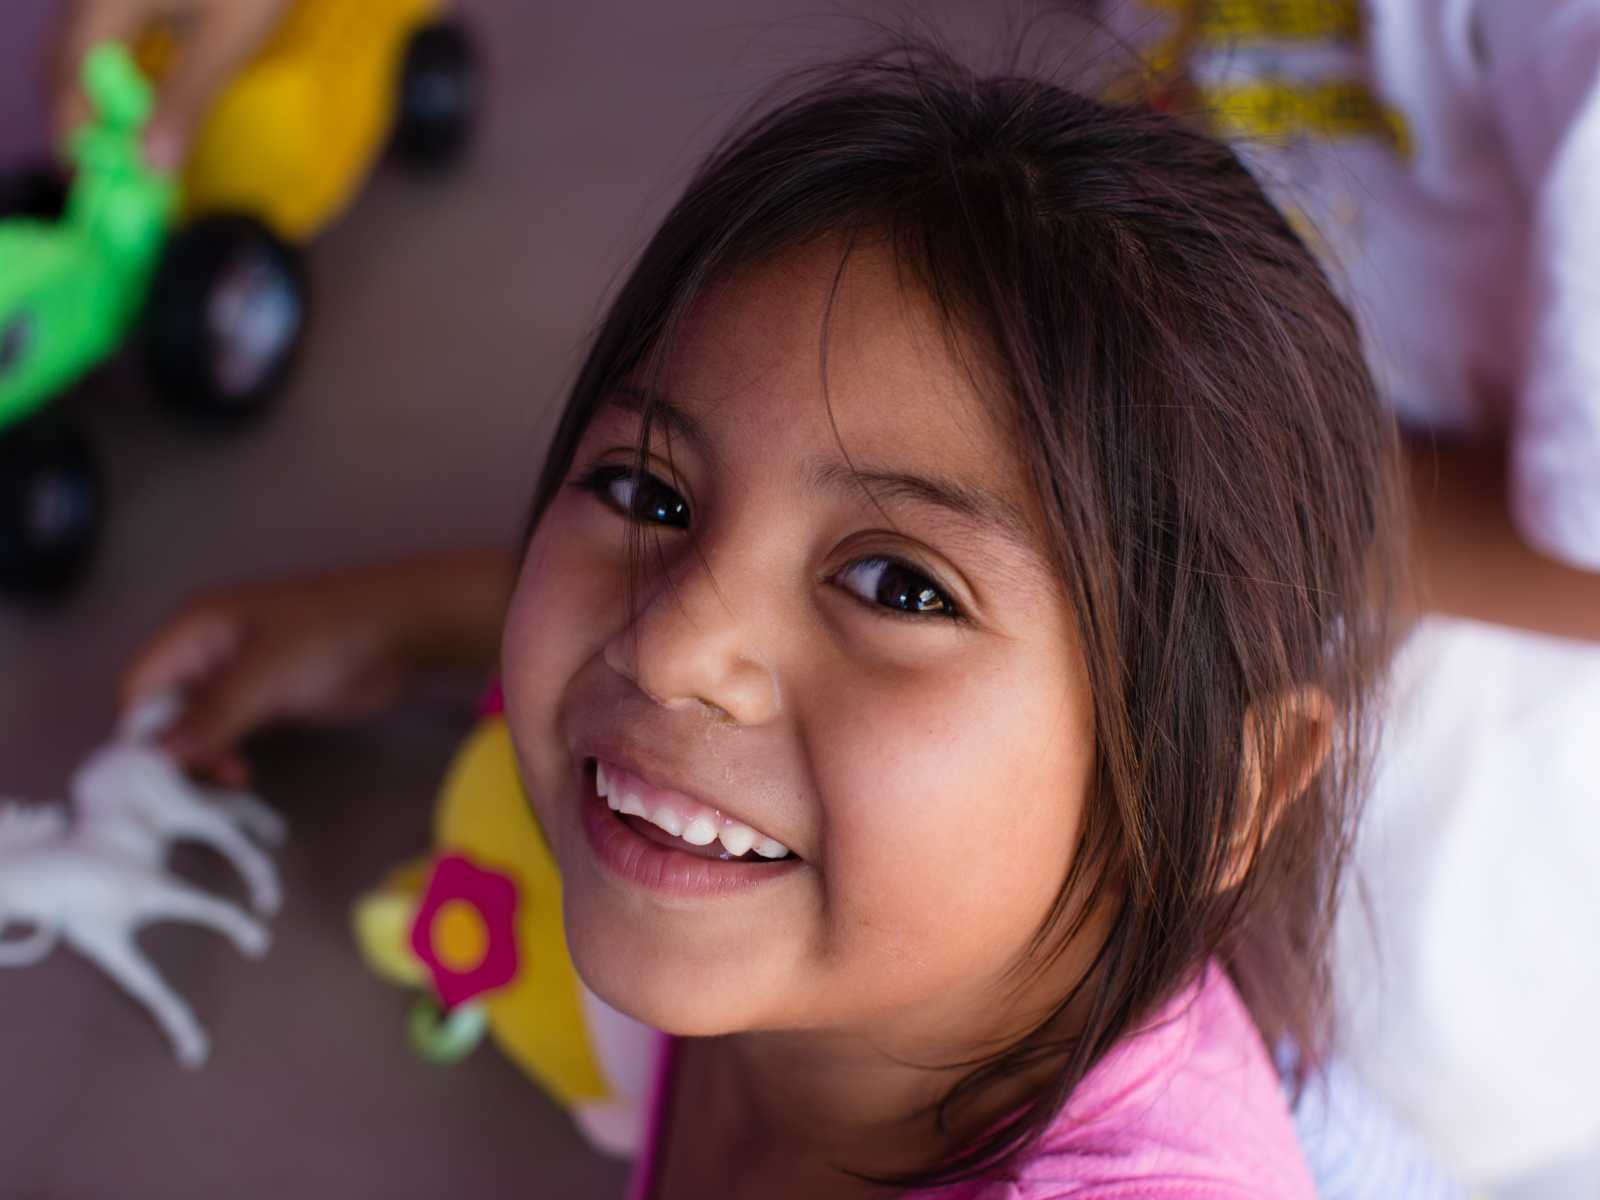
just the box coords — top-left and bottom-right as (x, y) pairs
(144, 214), (306, 422)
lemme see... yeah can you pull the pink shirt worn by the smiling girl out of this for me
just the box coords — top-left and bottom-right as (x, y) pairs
(630, 966), (1317, 1200)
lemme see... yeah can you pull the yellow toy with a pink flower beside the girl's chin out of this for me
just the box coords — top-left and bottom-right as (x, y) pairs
(354, 700), (656, 1154)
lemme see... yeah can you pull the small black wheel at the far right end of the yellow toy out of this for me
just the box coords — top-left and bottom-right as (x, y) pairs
(394, 21), (483, 168)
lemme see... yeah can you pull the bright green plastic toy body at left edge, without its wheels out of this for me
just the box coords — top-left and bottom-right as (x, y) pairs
(0, 45), (178, 429)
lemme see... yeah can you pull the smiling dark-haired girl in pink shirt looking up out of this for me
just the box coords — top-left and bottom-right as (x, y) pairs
(124, 42), (1392, 1200)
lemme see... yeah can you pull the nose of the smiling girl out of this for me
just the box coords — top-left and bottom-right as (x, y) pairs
(605, 552), (782, 726)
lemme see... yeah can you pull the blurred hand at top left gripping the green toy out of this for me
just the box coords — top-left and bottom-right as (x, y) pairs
(53, 0), (288, 171)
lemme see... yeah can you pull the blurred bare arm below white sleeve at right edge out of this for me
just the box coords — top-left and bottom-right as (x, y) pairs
(1406, 442), (1600, 642)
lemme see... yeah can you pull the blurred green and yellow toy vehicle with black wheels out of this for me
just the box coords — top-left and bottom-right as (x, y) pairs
(0, 0), (478, 592)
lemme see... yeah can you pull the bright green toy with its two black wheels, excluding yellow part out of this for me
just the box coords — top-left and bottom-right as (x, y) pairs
(0, 43), (306, 600)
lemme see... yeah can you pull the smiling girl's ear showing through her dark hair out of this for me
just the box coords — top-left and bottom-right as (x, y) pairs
(1221, 688), (1336, 891)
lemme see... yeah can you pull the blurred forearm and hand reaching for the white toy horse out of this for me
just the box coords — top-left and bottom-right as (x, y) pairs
(123, 550), (517, 786)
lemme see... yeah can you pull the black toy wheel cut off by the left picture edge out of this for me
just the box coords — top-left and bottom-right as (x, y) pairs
(0, 419), (106, 598)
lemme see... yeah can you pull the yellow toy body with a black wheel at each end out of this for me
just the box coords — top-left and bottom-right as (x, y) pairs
(138, 0), (478, 416)
